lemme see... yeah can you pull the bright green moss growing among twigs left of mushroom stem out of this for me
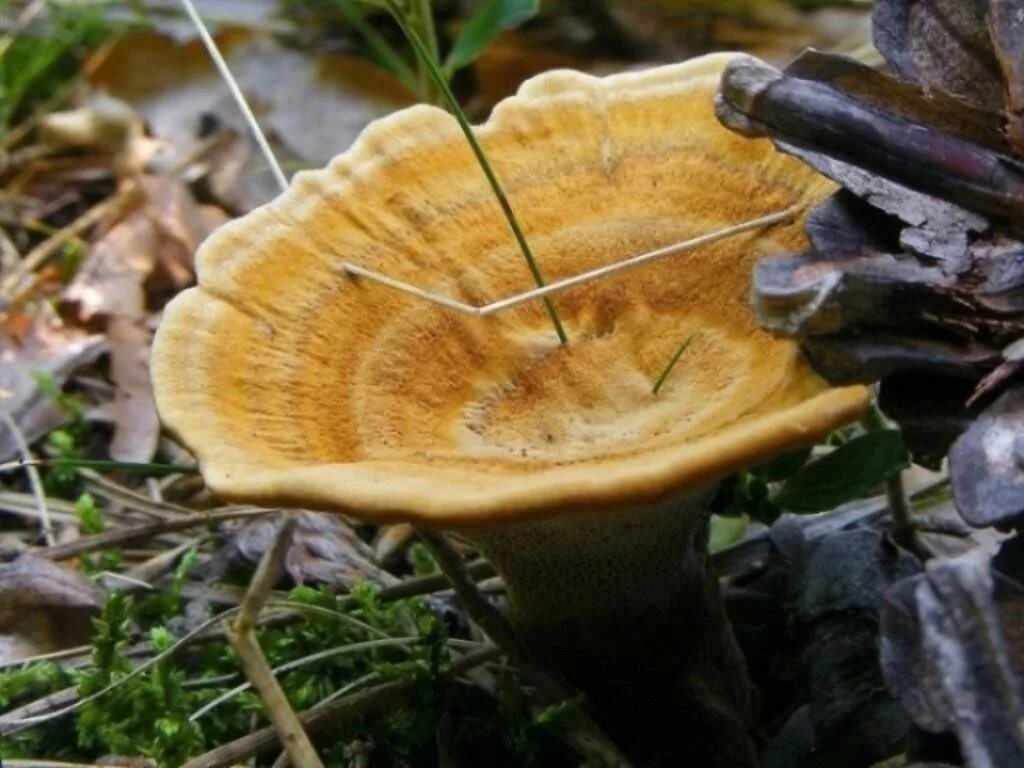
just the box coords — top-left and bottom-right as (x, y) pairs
(0, 581), (570, 768)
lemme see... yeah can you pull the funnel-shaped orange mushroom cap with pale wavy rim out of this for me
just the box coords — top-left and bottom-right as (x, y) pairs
(153, 55), (866, 527)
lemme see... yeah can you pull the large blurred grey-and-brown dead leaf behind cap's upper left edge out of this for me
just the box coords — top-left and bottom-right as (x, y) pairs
(92, 30), (414, 210)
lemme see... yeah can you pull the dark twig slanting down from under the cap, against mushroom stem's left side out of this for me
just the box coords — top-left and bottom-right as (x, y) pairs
(419, 529), (632, 768)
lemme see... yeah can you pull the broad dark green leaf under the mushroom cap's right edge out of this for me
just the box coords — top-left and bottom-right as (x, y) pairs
(772, 429), (909, 512)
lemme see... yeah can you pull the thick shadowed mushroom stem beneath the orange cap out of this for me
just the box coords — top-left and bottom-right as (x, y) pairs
(463, 489), (758, 768)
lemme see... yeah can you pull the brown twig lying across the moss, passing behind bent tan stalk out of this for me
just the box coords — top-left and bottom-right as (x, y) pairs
(182, 647), (501, 768)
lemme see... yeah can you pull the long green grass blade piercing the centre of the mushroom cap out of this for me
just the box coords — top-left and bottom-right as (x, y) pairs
(387, 0), (568, 344)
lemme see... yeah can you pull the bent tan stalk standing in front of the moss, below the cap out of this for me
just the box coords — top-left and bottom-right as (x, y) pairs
(224, 516), (324, 768)
